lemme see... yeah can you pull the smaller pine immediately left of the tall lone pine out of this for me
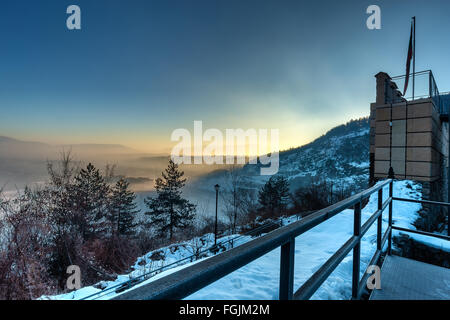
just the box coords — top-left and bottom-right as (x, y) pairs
(110, 178), (139, 236)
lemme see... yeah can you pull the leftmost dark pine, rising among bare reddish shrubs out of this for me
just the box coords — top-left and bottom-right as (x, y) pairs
(71, 163), (109, 239)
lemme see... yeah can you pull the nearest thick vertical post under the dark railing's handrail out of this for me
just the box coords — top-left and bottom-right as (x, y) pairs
(279, 238), (295, 300)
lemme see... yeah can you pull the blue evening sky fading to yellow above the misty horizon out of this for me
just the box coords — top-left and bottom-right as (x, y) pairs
(0, 0), (450, 153)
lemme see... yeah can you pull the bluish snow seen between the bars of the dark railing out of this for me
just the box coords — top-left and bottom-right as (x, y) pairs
(187, 181), (420, 300)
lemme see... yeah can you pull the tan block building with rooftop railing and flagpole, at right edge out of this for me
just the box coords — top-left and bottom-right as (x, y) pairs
(370, 70), (450, 201)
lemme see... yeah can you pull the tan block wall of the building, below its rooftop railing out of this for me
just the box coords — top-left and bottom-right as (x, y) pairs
(373, 99), (443, 182)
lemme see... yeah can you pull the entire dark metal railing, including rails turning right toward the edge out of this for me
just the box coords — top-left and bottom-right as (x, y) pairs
(110, 179), (450, 300)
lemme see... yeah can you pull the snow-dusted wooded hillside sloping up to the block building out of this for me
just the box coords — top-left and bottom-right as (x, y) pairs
(189, 118), (369, 190)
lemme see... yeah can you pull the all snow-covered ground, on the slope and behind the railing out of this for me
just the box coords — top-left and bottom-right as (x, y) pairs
(43, 181), (450, 300)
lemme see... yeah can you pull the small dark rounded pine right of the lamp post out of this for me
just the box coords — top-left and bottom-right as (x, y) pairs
(258, 176), (289, 216)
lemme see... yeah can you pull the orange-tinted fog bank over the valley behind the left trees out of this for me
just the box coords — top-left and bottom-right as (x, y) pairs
(0, 136), (239, 206)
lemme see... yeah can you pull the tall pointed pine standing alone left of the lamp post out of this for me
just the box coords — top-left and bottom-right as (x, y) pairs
(145, 159), (195, 240)
